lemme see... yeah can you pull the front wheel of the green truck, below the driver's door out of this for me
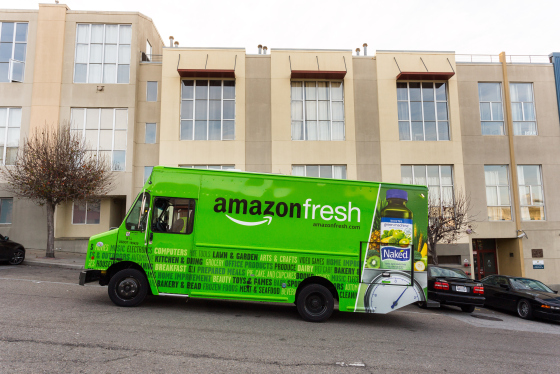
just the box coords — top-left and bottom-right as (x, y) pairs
(109, 269), (149, 307)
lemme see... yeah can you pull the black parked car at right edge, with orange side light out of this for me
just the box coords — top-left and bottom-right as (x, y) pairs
(481, 275), (560, 321)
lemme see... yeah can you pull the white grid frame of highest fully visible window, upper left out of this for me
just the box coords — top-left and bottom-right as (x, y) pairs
(72, 22), (133, 84)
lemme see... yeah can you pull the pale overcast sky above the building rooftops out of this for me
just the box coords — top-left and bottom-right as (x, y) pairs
(4, 0), (560, 55)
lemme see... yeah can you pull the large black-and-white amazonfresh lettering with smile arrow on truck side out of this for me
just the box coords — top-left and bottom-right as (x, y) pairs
(214, 197), (360, 226)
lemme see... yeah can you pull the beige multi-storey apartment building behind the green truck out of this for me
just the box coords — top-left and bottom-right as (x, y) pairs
(0, 4), (560, 285)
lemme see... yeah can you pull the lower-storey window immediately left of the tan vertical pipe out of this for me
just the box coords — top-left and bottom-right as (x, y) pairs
(484, 165), (511, 221)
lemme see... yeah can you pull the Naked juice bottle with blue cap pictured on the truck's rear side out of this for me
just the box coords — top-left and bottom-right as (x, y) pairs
(380, 190), (413, 271)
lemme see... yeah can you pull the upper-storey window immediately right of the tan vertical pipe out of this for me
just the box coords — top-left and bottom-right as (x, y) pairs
(509, 83), (537, 135)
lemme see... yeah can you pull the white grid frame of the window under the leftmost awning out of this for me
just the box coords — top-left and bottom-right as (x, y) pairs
(179, 78), (237, 141)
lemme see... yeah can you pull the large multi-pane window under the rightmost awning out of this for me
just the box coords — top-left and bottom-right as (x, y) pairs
(397, 82), (449, 141)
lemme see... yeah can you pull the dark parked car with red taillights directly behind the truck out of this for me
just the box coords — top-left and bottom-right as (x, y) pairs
(419, 265), (484, 313)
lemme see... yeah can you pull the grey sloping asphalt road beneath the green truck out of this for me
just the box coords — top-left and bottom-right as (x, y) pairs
(0, 265), (560, 373)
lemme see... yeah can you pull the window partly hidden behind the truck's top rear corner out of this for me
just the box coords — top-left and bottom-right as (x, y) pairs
(401, 165), (453, 208)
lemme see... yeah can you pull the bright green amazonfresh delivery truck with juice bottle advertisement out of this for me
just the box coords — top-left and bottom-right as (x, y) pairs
(80, 166), (428, 322)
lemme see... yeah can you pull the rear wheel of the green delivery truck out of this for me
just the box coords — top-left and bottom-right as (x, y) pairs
(296, 284), (334, 322)
